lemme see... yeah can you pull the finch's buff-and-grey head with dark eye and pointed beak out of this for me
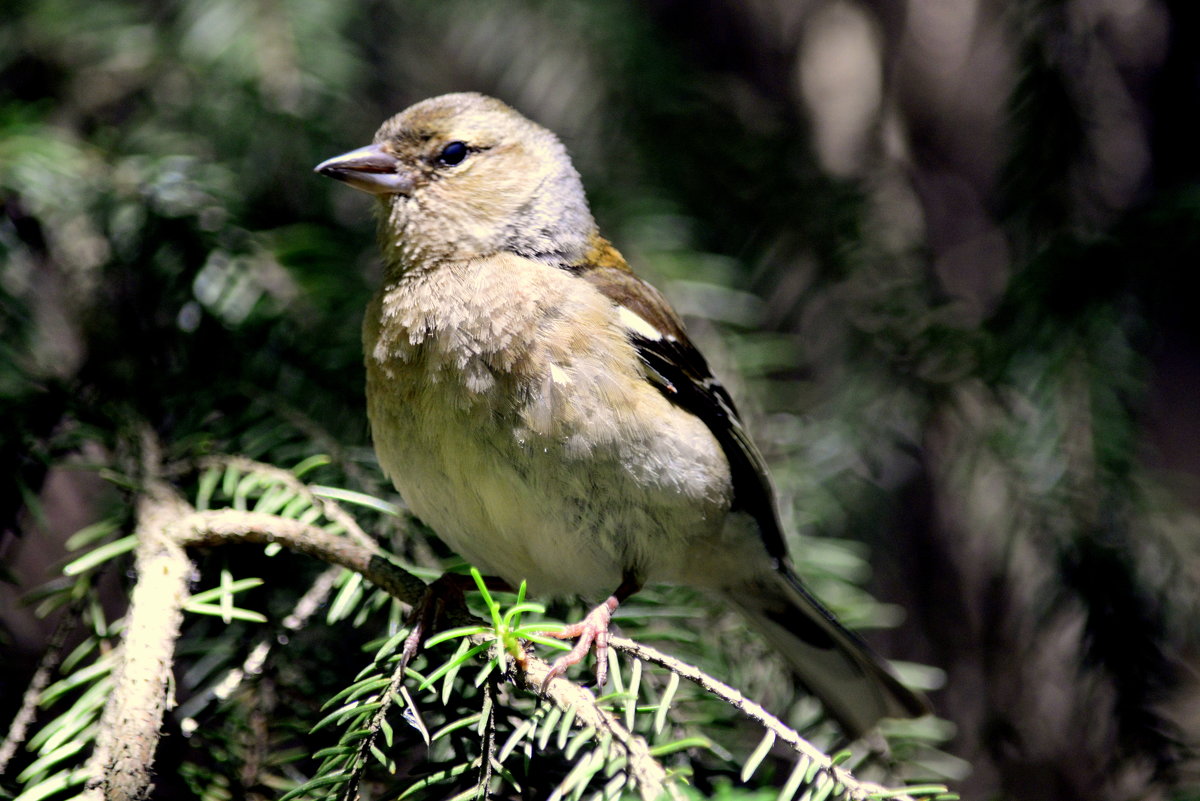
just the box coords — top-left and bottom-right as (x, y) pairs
(316, 92), (595, 270)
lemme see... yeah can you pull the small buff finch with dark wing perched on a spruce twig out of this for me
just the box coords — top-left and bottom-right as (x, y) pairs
(316, 92), (929, 739)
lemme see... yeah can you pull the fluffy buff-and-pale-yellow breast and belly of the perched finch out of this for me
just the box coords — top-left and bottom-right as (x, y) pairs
(364, 255), (732, 597)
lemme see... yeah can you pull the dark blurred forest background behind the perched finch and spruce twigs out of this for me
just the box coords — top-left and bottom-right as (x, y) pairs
(0, 0), (1200, 800)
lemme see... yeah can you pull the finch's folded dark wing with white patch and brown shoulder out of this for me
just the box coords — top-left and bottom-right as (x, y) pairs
(566, 237), (787, 564)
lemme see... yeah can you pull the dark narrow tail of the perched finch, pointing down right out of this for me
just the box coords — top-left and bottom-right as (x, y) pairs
(724, 567), (930, 739)
